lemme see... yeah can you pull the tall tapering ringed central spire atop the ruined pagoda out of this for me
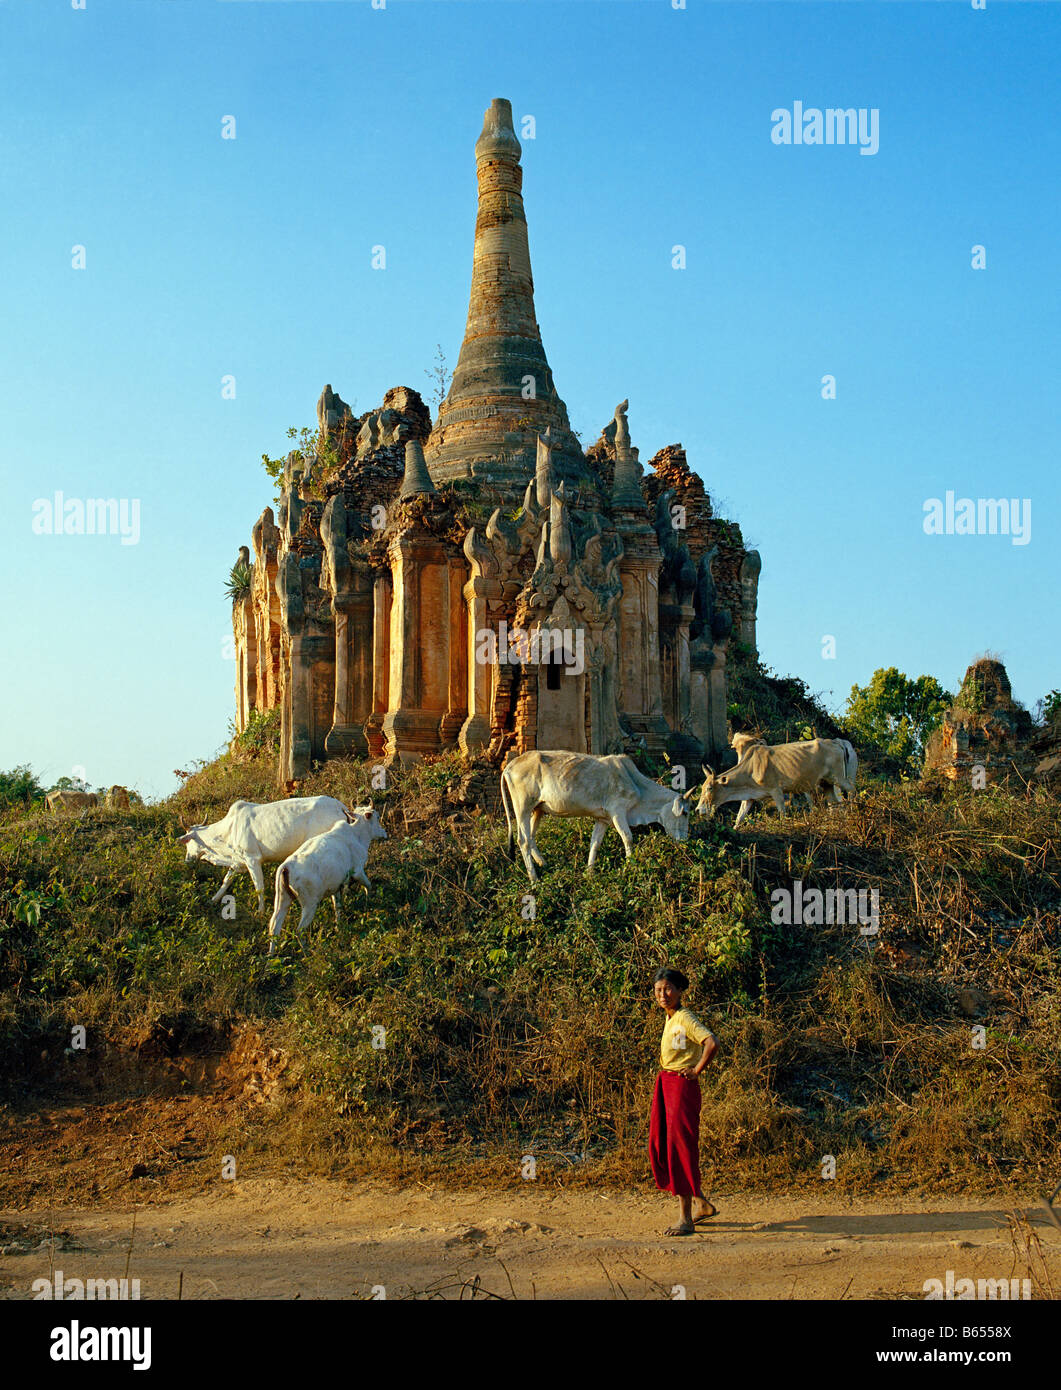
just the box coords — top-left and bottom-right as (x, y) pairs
(426, 97), (591, 502)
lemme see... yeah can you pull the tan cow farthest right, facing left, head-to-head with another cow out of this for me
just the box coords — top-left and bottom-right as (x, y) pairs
(697, 738), (857, 830)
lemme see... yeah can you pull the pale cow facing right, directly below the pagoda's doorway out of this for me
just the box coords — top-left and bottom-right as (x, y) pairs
(501, 752), (695, 883)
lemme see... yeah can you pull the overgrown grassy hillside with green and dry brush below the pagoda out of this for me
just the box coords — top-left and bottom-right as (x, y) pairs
(0, 752), (1061, 1191)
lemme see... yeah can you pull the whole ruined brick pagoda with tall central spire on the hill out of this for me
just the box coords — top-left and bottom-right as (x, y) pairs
(232, 100), (759, 785)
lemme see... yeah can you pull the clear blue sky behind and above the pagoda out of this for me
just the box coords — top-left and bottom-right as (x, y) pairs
(0, 0), (1061, 796)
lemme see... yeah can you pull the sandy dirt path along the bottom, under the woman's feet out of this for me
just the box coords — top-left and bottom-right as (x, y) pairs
(0, 1179), (1061, 1298)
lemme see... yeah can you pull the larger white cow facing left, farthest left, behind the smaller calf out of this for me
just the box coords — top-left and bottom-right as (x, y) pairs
(177, 796), (353, 912)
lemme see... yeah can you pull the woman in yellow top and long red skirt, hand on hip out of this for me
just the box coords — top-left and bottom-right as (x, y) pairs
(648, 970), (719, 1236)
